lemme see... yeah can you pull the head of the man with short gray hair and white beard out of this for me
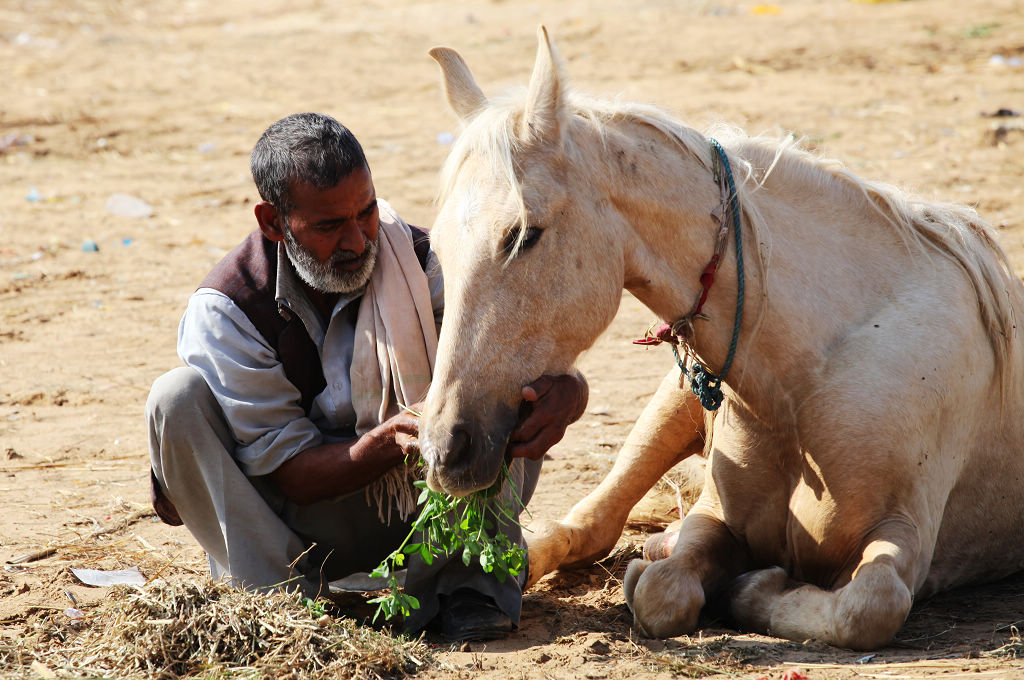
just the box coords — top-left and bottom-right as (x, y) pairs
(250, 114), (378, 293)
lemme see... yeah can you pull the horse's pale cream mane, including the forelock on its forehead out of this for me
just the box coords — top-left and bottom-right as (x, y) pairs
(438, 90), (1019, 387)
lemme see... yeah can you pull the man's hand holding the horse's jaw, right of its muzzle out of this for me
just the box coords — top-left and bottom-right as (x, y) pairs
(508, 374), (590, 461)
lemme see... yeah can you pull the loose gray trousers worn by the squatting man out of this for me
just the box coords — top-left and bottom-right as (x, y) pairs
(145, 367), (541, 631)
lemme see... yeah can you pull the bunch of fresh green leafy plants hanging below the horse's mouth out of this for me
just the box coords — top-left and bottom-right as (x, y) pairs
(369, 465), (526, 621)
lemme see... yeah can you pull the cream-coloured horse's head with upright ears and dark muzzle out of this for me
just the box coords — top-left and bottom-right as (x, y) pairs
(421, 29), (624, 495)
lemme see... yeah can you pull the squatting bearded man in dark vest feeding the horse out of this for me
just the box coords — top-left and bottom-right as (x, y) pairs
(146, 114), (587, 641)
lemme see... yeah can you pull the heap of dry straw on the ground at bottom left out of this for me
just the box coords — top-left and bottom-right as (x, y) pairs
(0, 580), (436, 680)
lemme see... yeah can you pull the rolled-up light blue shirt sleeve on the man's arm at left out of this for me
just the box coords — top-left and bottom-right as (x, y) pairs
(178, 288), (324, 477)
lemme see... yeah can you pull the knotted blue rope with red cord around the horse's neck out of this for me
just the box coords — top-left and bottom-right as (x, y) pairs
(662, 138), (743, 411)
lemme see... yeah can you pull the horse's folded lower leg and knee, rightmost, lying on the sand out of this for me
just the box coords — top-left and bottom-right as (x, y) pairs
(730, 519), (921, 649)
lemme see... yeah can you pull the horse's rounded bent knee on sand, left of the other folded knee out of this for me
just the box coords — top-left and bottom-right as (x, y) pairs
(623, 559), (705, 638)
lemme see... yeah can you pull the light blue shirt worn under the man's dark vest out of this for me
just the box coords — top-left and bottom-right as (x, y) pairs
(178, 227), (444, 476)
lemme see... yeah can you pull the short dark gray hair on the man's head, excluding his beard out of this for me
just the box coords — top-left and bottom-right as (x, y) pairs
(249, 114), (367, 215)
